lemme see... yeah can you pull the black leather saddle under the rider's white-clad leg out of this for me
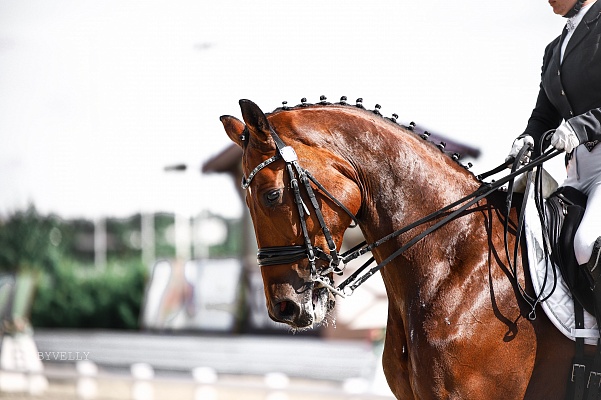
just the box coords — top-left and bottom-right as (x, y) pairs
(545, 186), (595, 315)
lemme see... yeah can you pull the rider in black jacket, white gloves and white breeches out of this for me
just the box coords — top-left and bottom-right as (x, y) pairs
(508, 0), (601, 282)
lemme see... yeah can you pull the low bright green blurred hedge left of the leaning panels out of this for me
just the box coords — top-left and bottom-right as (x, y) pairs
(31, 262), (147, 329)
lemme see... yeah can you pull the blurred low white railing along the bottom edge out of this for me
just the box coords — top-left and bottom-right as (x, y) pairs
(0, 360), (392, 400)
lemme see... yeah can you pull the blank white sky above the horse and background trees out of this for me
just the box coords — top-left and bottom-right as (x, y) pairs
(0, 0), (565, 217)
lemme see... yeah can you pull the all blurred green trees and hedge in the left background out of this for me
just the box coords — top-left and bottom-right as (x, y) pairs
(0, 206), (242, 329)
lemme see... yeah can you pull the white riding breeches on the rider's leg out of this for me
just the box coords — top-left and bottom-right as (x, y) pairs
(562, 144), (601, 265)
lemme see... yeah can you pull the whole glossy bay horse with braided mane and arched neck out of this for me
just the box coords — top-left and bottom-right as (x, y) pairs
(221, 100), (591, 400)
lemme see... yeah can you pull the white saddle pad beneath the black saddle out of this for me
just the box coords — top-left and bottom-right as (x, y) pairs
(524, 178), (599, 344)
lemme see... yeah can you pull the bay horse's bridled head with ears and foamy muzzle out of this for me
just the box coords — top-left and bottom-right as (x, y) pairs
(221, 100), (361, 329)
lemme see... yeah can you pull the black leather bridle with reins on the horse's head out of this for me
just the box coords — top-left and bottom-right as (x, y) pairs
(241, 129), (561, 303)
